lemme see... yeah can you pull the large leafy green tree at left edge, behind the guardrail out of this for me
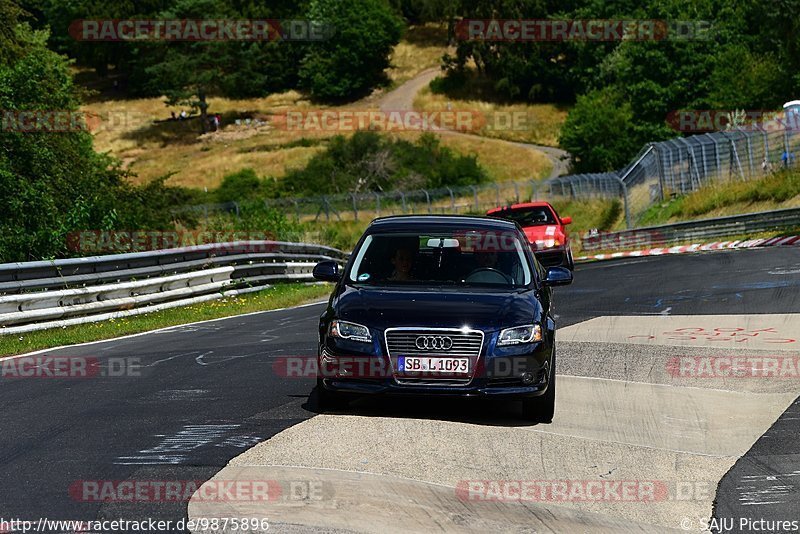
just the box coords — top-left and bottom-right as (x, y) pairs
(0, 22), (122, 261)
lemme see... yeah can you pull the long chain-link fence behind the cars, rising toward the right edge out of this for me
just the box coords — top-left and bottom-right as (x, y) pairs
(172, 128), (800, 228)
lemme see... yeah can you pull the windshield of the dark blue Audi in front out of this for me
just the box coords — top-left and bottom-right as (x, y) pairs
(349, 230), (531, 289)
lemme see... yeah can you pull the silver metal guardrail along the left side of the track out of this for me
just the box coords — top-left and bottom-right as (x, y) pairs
(0, 241), (347, 334)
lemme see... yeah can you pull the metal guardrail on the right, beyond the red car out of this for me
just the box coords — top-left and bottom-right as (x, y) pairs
(581, 208), (800, 251)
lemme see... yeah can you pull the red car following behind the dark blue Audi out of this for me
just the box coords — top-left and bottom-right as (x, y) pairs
(486, 202), (575, 270)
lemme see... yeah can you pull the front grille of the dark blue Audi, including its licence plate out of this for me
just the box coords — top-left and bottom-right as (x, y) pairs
(384, 328), (483, 385)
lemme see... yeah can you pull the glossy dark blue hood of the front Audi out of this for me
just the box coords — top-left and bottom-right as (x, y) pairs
(334, 286), (541, 330)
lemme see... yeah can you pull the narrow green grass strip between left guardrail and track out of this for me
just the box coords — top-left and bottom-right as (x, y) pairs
(0, 284), (331, 356)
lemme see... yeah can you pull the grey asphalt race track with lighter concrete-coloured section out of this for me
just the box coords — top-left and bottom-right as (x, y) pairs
(0, 248), (800, 532)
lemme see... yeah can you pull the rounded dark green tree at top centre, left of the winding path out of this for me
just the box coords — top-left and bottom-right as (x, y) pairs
(299, 0), (403, 101)
